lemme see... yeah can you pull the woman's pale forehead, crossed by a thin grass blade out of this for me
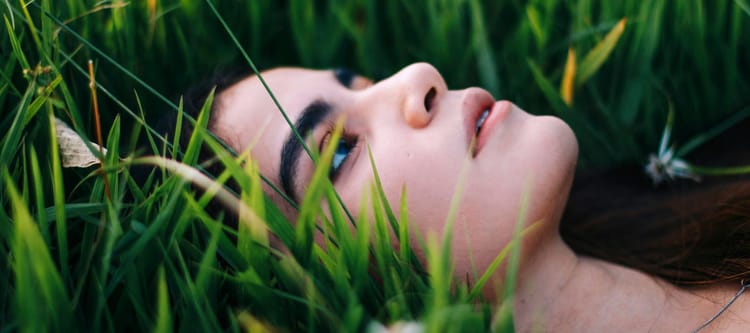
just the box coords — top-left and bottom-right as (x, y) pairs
(212, 68), (343, 183)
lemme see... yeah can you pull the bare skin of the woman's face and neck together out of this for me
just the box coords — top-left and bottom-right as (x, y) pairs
(169, 63), (750, 332)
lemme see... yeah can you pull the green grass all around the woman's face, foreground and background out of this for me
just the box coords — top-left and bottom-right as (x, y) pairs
(0, 0), (750, 332)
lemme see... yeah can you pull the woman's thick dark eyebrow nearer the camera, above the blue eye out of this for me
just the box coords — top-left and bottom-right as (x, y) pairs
(279, 99), (332, 202)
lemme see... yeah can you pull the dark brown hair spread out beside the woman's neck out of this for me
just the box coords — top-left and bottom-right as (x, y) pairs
(561, 116), (750, 285)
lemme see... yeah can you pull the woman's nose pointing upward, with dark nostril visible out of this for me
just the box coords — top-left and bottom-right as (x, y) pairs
(389, 63), (447, 128)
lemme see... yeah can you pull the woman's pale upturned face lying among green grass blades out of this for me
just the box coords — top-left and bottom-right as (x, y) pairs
(211, 63), (577, 276)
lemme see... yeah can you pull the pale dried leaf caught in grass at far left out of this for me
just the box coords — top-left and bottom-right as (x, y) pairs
(55, 117), (107, 168)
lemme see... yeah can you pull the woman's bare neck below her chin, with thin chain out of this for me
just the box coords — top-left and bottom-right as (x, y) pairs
(514, 235), (750, 332)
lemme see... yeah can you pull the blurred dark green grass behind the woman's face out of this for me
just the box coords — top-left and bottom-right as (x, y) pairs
(0, 0), (750, 167)
